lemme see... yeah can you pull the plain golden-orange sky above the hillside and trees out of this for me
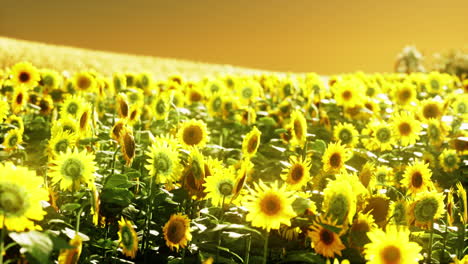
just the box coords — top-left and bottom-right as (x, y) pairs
(0, 0), (468, 74)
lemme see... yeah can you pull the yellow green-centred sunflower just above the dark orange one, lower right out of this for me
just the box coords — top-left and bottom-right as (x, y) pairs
(322, 178), (357, 225)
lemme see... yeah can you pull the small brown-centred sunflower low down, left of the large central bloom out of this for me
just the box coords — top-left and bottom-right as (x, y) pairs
(163, 214), (192, 251)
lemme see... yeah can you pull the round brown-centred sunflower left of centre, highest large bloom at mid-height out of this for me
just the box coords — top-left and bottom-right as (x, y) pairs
(178, 119), (208, 148)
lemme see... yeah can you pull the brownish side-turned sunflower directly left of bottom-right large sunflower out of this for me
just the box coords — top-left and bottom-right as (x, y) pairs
(349, 212), (377, 249)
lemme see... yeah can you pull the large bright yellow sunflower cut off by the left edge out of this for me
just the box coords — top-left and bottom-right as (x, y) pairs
(0, 162), (48, 232)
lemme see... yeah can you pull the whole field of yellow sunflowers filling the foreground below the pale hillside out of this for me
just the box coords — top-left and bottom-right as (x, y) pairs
(0, 59), (468, 264)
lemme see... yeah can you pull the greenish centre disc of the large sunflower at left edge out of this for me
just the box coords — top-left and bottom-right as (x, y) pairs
(0, 185), (27, 215)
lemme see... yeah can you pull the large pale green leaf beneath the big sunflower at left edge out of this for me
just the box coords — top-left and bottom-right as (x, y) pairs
(10, 231), (53, 263)
